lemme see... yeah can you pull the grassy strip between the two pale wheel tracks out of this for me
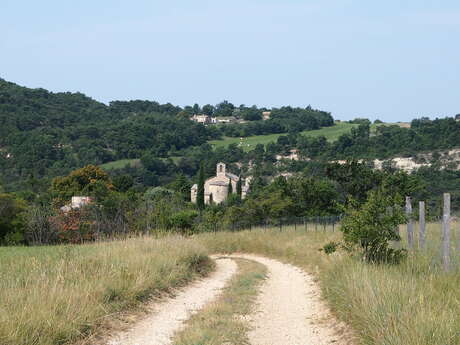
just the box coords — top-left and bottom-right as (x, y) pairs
(174, 259), (266, 345)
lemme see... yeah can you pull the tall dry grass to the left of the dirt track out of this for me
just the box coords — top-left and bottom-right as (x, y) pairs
(0, 237), (213, 345)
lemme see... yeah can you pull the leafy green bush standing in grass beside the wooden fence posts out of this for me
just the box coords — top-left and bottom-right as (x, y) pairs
(341, 190), (405, 263)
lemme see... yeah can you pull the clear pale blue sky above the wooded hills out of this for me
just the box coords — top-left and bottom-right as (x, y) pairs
(0, 0), (460, 122)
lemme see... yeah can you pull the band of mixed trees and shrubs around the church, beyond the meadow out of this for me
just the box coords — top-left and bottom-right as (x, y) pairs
(0, 162), (424, 244)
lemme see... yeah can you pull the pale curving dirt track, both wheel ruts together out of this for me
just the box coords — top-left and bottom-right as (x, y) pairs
(107, 254), (350, 345)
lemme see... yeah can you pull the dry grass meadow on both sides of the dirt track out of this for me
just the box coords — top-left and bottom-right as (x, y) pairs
(0, 223), (460, 345)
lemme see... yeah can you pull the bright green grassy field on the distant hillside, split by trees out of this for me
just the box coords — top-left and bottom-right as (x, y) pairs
(209, 122), (358, 151)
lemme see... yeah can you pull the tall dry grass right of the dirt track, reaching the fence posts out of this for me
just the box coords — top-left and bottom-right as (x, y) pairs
(198, 224), (460, 345)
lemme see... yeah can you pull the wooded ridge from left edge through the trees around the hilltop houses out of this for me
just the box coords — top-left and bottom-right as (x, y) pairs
(0, 79), (334, 190)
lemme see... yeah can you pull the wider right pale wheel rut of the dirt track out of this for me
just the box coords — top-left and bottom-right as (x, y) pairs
(227, 254), (349, 345)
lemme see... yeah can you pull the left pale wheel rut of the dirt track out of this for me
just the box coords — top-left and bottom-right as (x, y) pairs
(107, 259), (237, 345)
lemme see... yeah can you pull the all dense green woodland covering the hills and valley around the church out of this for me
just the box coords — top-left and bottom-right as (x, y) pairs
(0, 80), (460, 244)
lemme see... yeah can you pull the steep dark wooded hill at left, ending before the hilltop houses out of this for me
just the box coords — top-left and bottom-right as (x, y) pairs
(0, 79), (210, 188)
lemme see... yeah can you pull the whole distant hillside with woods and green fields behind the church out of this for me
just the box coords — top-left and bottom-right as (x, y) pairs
(0, 79), (460, 196)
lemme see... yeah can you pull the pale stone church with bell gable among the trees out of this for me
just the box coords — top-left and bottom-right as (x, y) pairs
(191, 163), (249, 204)
